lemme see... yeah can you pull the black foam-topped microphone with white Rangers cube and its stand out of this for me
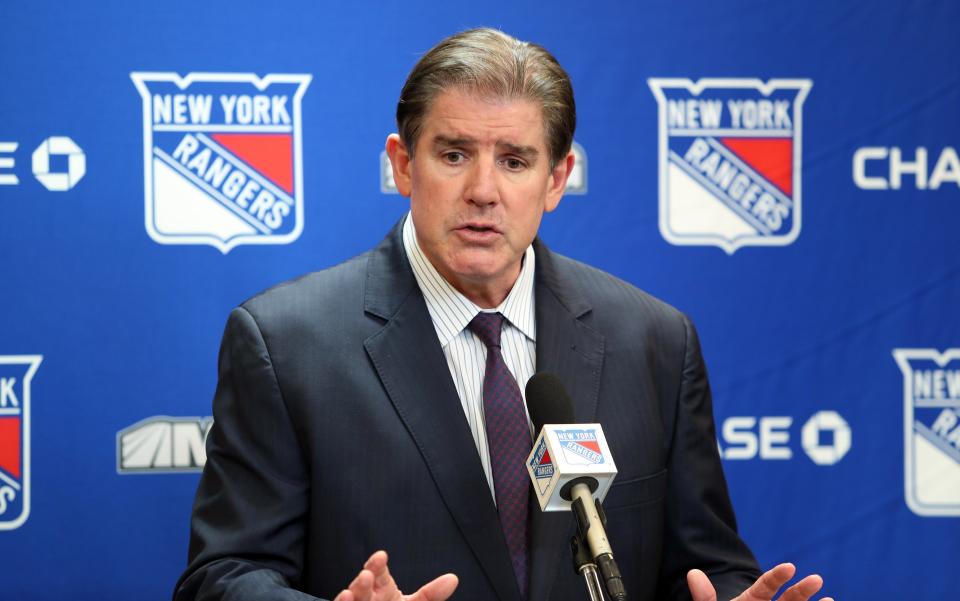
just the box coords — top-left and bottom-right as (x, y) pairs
(526, 372), (627, 601)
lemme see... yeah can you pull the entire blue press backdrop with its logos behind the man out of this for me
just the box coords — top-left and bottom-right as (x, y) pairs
(0, 0), (960, 600)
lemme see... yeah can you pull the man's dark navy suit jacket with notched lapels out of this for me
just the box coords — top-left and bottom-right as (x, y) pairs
(175, 221), (758, 601)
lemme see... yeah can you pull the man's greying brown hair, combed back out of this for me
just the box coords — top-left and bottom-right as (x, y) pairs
(397, 28), (577, 168)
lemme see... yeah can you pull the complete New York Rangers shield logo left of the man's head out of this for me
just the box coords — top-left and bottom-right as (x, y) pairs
(130, 73), (311, 253)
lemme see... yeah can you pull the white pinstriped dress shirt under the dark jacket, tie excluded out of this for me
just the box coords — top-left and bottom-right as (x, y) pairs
(403, 213), (537, 503)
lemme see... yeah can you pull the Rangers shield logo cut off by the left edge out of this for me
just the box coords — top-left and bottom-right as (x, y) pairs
(0, 355), (43, 530)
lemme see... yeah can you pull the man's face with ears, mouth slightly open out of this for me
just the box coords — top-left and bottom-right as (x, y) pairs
(387, 89), (573, 307)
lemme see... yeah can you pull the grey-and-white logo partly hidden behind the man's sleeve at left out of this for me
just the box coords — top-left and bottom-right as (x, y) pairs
(117, 415), (213, 474)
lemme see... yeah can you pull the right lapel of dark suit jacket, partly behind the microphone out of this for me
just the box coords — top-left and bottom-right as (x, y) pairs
(530, 241), (604, 601)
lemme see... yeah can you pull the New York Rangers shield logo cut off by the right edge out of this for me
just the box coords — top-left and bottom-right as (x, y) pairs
(893, 349), (960, 516)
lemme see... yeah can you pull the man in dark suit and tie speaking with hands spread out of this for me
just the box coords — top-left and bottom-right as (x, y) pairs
(175, 29), (821, 601)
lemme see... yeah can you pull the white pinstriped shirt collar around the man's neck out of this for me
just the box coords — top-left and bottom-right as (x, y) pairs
(403, 213), (537, 346)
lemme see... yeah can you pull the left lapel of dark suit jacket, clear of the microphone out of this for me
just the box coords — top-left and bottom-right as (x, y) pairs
(364, 227), (520, 601)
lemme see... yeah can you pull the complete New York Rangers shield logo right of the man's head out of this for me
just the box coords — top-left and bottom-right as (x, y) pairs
(649, 78), (813, 254)
